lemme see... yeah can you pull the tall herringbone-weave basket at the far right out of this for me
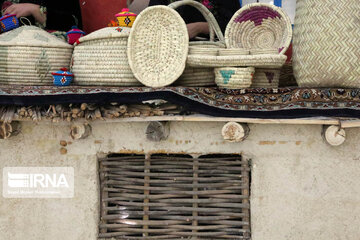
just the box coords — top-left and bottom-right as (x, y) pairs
(293, 0), (360, 88)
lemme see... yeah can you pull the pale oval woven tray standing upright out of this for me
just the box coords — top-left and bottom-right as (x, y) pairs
(128, 6), (189, 87)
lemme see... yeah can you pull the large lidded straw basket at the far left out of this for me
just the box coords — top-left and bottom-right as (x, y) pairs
(0, 26), (73, 85)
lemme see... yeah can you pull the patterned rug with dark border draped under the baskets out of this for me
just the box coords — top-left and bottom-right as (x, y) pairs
(0, 86), (360, 118)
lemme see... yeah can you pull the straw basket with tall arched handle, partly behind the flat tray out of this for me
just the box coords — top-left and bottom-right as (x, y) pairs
(169, 0), (225, 87)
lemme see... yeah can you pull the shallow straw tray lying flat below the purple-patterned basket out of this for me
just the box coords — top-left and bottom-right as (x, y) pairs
(187, 54), (287, 68)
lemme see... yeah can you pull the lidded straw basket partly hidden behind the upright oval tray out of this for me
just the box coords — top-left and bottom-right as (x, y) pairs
(71, 27), (142, 86)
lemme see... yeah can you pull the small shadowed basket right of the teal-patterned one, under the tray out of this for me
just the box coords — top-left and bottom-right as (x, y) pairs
(251, 68), (280, 88)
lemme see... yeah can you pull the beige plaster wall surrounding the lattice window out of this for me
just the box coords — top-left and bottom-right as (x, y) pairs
(0, 122), (360, 240)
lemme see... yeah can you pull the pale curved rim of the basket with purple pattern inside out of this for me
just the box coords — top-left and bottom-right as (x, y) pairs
(225, 3), (293, 54)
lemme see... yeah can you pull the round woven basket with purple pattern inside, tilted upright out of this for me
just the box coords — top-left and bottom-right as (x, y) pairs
(225, 3), (292, 54)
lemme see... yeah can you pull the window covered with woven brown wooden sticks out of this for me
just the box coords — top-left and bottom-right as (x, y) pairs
(99, 155), (250, 240)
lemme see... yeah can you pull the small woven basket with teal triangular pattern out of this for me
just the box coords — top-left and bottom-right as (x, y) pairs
(214, 67), (255, 89)
